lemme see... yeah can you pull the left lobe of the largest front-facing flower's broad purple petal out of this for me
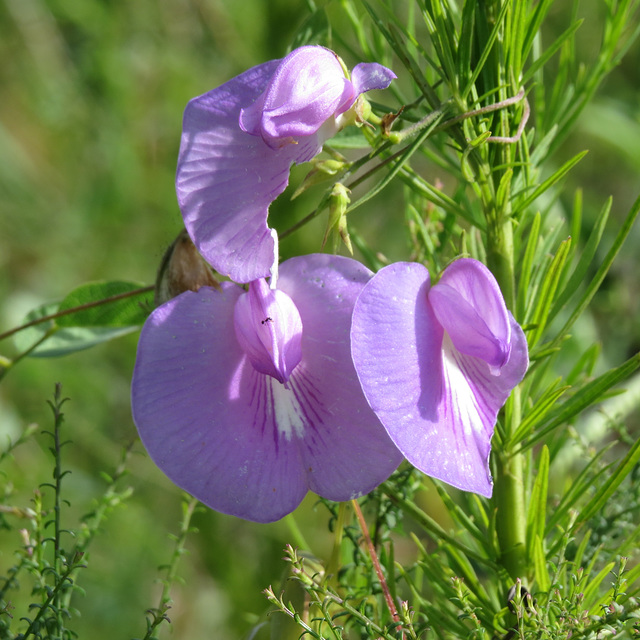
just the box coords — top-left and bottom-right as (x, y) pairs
(132, 283), (307, 522)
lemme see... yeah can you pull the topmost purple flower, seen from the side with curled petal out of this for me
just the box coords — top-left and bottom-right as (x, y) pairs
(176, 46), (395, 282)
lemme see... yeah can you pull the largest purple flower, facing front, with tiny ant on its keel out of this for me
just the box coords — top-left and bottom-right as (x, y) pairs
(132, 254), (402, 522)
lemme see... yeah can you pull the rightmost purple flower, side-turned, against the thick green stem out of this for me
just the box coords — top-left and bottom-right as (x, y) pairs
(351, 259), (529, 497)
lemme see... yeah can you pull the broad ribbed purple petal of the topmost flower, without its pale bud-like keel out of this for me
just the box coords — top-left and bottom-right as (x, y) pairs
(176, 60), (322, 282)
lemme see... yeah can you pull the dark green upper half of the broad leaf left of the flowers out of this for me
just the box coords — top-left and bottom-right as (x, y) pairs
(56, 281), (154, 327)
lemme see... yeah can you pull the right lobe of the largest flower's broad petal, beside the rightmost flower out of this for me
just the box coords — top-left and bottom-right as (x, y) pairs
(278, 254), (402, 501)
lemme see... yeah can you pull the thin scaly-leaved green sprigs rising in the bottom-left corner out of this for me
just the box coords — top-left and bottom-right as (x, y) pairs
(0, 385), (197, 640)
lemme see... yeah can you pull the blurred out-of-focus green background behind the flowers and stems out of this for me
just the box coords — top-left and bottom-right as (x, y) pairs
(0, 0), (640, 640)
